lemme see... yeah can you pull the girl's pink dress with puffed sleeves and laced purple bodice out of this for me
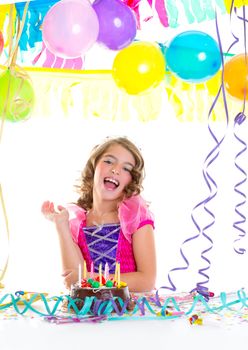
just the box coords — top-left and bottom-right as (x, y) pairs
(67, 196), (154, 273)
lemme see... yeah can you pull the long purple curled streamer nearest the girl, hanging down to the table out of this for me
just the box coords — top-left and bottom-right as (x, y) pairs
(157, 10), (229, 295)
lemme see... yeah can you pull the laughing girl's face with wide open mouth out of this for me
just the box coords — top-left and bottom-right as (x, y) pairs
(93, 144), (135, 200)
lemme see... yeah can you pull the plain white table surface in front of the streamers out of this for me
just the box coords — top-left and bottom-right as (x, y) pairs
(0, 292), (248, 350)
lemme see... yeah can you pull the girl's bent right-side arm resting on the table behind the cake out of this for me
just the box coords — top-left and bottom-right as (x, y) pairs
(118, 225), (156, 292)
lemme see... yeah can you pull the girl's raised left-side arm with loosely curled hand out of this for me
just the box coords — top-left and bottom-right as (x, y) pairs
(41, 201), (83, 288)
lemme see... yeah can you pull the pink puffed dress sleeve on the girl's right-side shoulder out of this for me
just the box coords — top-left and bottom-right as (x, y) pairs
(118, 195), (154, 242)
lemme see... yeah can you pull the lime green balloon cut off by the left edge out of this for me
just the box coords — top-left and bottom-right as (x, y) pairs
(0, 69), (35, 122)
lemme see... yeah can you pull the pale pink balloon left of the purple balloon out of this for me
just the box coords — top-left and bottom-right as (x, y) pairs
(42, 0), (99, 58)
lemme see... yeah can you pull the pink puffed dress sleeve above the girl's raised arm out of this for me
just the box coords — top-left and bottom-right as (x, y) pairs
(66, 204), (86, 243)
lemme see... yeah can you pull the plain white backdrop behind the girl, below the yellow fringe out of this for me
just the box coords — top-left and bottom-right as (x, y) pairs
(1, 111), (248, 291)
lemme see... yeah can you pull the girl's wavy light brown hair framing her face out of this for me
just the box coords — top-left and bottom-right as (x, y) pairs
(75, 137), (145, 210)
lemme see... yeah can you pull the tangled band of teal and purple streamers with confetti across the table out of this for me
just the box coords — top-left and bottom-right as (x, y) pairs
(0, 289), (248, 324)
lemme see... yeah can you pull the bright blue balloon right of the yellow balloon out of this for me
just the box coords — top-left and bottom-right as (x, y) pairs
(165, 30), (221, 83)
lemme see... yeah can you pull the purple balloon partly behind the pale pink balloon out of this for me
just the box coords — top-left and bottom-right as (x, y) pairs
(93, 0), (137, 50)
